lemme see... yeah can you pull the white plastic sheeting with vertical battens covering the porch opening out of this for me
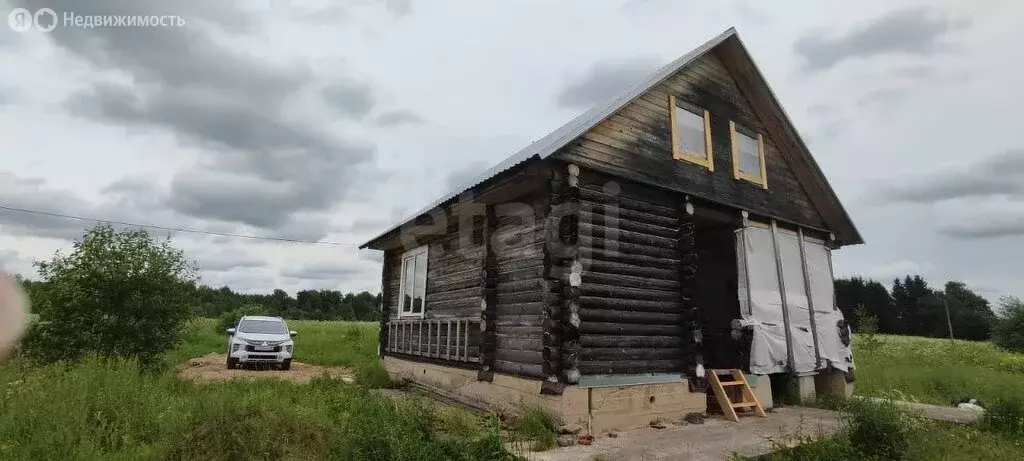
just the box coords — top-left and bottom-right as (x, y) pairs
(736, 226), (852, 375)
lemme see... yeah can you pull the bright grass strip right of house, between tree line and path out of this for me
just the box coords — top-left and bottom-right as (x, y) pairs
(853, 335), (1024, 405)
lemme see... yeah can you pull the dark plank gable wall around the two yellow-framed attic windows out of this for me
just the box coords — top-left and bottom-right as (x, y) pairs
(558, 49), (825, 228)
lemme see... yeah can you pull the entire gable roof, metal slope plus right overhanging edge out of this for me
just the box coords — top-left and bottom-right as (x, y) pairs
(359, 28), (863, 249)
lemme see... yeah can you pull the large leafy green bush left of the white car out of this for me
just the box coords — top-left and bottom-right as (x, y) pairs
(23, 224), (196, 365)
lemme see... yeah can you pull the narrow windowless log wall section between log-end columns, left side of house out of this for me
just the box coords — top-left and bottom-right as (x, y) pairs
(490, 192), (546, 378)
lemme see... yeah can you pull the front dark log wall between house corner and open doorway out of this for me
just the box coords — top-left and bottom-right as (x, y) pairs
(579, 169), (698, 375)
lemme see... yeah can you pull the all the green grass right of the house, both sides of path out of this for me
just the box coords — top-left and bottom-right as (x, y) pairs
(769, 335), (1024, 461)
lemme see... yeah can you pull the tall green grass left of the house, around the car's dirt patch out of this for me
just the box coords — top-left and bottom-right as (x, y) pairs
(0, 319), (510, 461)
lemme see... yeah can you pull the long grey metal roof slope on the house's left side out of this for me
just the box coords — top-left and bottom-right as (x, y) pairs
(359, 28), (736, 248)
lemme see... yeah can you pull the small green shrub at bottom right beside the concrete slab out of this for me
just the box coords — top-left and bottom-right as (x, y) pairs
(844, 400), (921, 460)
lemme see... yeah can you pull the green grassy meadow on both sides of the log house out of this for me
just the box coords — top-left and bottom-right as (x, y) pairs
(0, 319), (1024, 461)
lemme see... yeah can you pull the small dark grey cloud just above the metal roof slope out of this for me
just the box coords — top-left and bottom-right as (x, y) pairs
(555, 57), (658, 109)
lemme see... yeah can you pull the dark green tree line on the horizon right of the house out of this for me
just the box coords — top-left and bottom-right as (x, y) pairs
(836, 276), (998, 340)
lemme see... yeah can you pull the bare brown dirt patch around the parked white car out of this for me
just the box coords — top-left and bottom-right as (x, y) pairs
(176, 353), (355, 383)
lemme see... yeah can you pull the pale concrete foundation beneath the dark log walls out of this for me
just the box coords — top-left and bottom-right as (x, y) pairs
(383, 357), (708, 433)
